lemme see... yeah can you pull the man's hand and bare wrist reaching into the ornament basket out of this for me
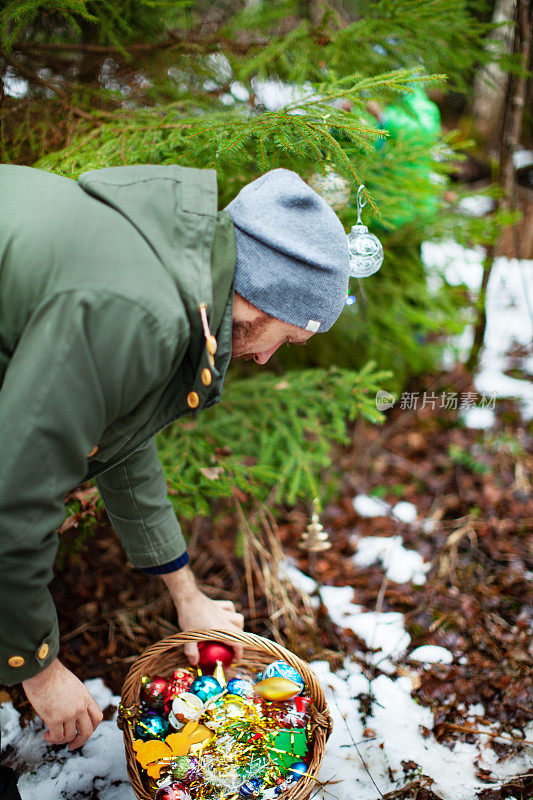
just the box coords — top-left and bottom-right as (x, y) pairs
(161, 566), (244, 664)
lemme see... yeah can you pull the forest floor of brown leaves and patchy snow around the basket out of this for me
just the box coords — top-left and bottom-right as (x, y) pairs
(0, 370), (533, 800)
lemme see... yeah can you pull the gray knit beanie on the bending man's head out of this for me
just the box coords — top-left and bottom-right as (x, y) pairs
(224, 169), (350, 333)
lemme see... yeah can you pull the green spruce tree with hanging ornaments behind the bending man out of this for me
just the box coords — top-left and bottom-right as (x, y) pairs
(0, 0), (510, 515)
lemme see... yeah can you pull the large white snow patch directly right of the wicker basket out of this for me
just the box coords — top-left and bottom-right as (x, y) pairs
(311, 660), (533, 800)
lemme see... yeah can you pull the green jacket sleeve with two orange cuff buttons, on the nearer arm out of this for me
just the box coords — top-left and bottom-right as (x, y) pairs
(0, 290), (179, 685)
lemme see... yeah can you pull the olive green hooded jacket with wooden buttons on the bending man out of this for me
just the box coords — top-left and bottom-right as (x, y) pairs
(0, 165), (236, 685)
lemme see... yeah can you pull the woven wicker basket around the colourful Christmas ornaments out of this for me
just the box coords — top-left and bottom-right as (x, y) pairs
(118, 630), (332, 800)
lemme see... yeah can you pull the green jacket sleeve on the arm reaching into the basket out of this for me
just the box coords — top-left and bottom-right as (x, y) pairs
(96, 438), (187, 574)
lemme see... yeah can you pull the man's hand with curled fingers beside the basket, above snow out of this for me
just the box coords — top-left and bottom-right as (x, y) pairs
(22, 658), (103, 750)
